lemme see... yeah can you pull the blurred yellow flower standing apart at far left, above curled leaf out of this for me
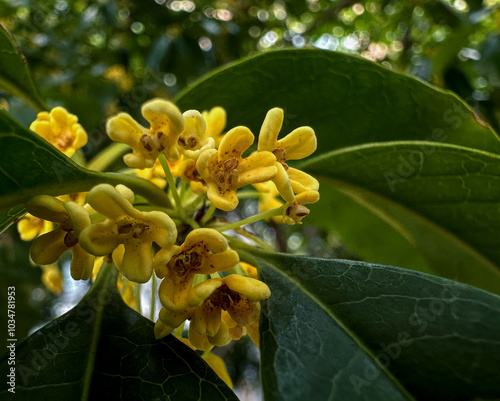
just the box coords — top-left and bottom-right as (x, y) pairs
(30, 107), (87, 157)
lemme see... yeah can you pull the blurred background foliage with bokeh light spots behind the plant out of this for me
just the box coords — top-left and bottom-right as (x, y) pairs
(0, 0), (500, 399)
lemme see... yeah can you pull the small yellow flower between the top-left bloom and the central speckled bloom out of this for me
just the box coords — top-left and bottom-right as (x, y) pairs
(177, 110), (215, 159)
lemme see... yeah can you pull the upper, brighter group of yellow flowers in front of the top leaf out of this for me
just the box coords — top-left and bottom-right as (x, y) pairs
(107, 99), (319, 220)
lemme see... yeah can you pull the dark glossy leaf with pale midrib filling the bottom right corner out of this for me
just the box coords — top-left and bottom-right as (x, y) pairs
(240, 248), (500, 401)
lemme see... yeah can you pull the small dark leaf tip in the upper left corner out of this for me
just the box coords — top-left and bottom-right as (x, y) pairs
(0, 24), (48, 111)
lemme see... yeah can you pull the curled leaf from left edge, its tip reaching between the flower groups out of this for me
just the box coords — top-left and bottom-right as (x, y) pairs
(0, 110), (170, 228)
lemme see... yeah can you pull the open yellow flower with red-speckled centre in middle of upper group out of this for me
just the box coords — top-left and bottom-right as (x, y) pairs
(196, 126), (277, 211)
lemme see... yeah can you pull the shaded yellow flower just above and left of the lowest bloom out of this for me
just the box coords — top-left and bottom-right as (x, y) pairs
(154, 228), (240, 309)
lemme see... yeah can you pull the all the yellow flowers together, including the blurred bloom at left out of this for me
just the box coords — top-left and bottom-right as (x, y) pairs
(18, 99), (319, 350)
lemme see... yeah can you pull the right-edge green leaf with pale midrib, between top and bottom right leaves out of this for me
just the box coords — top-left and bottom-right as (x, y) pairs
(303, 142), (500, 293)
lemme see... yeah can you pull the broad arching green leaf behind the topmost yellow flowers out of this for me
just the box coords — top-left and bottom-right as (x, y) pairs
(176, 49), (500, 154)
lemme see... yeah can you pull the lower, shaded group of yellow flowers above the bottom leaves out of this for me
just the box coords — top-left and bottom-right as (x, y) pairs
(21, 184), (270, 350)
